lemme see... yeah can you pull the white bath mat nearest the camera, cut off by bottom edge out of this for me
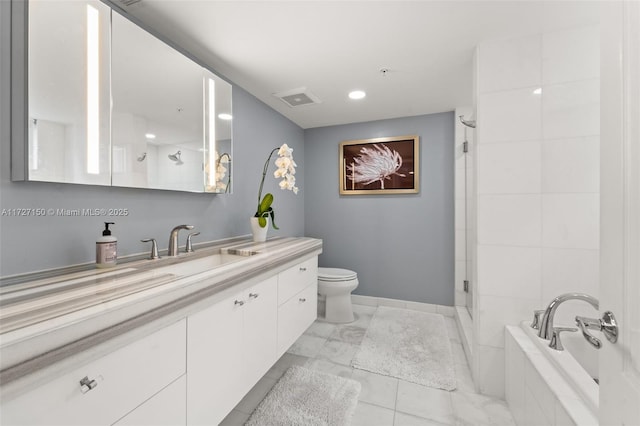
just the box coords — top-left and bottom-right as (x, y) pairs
(245, 365), (361, 426)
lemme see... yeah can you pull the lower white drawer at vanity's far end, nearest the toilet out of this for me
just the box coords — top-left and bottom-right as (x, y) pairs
(278, 282), (318, 357)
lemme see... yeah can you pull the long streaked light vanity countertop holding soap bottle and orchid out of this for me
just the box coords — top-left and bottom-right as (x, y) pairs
(0, 237), (322, 387)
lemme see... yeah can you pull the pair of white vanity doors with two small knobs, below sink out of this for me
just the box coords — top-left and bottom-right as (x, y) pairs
(187, 276), (278, 425)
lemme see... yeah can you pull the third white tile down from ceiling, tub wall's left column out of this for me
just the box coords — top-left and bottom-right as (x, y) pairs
(477, 141), (541, 194)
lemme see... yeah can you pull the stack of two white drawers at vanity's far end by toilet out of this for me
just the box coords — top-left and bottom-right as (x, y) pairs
(278, 257), (318, 357)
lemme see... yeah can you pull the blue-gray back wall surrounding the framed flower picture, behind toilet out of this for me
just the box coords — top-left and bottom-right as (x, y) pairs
(304, 112), (454, 305)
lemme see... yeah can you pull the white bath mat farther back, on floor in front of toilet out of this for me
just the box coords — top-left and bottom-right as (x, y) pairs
(351, 306), (456, 391)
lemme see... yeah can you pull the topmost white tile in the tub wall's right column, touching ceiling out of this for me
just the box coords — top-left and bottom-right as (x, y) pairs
(542, 25), (600, 84)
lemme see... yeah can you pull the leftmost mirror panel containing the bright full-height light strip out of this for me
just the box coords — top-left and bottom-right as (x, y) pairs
(28, 1), (111, 185)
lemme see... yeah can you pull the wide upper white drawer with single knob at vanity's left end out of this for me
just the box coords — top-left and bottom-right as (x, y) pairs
(0, 320), (186, 425)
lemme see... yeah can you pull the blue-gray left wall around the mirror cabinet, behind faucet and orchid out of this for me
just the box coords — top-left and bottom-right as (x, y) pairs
(0, 1), (305, 276)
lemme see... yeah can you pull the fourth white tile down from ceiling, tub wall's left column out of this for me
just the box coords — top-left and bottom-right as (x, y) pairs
(477, 195), (542, 247)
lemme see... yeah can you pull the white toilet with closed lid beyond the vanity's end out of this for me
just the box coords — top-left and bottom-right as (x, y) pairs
(318, 268), (358, 323)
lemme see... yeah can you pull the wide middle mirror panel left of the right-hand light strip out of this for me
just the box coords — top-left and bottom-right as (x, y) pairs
(111, 13), (204, 192)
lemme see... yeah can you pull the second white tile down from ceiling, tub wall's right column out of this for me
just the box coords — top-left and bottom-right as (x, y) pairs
(540, 79), (600, 139)
